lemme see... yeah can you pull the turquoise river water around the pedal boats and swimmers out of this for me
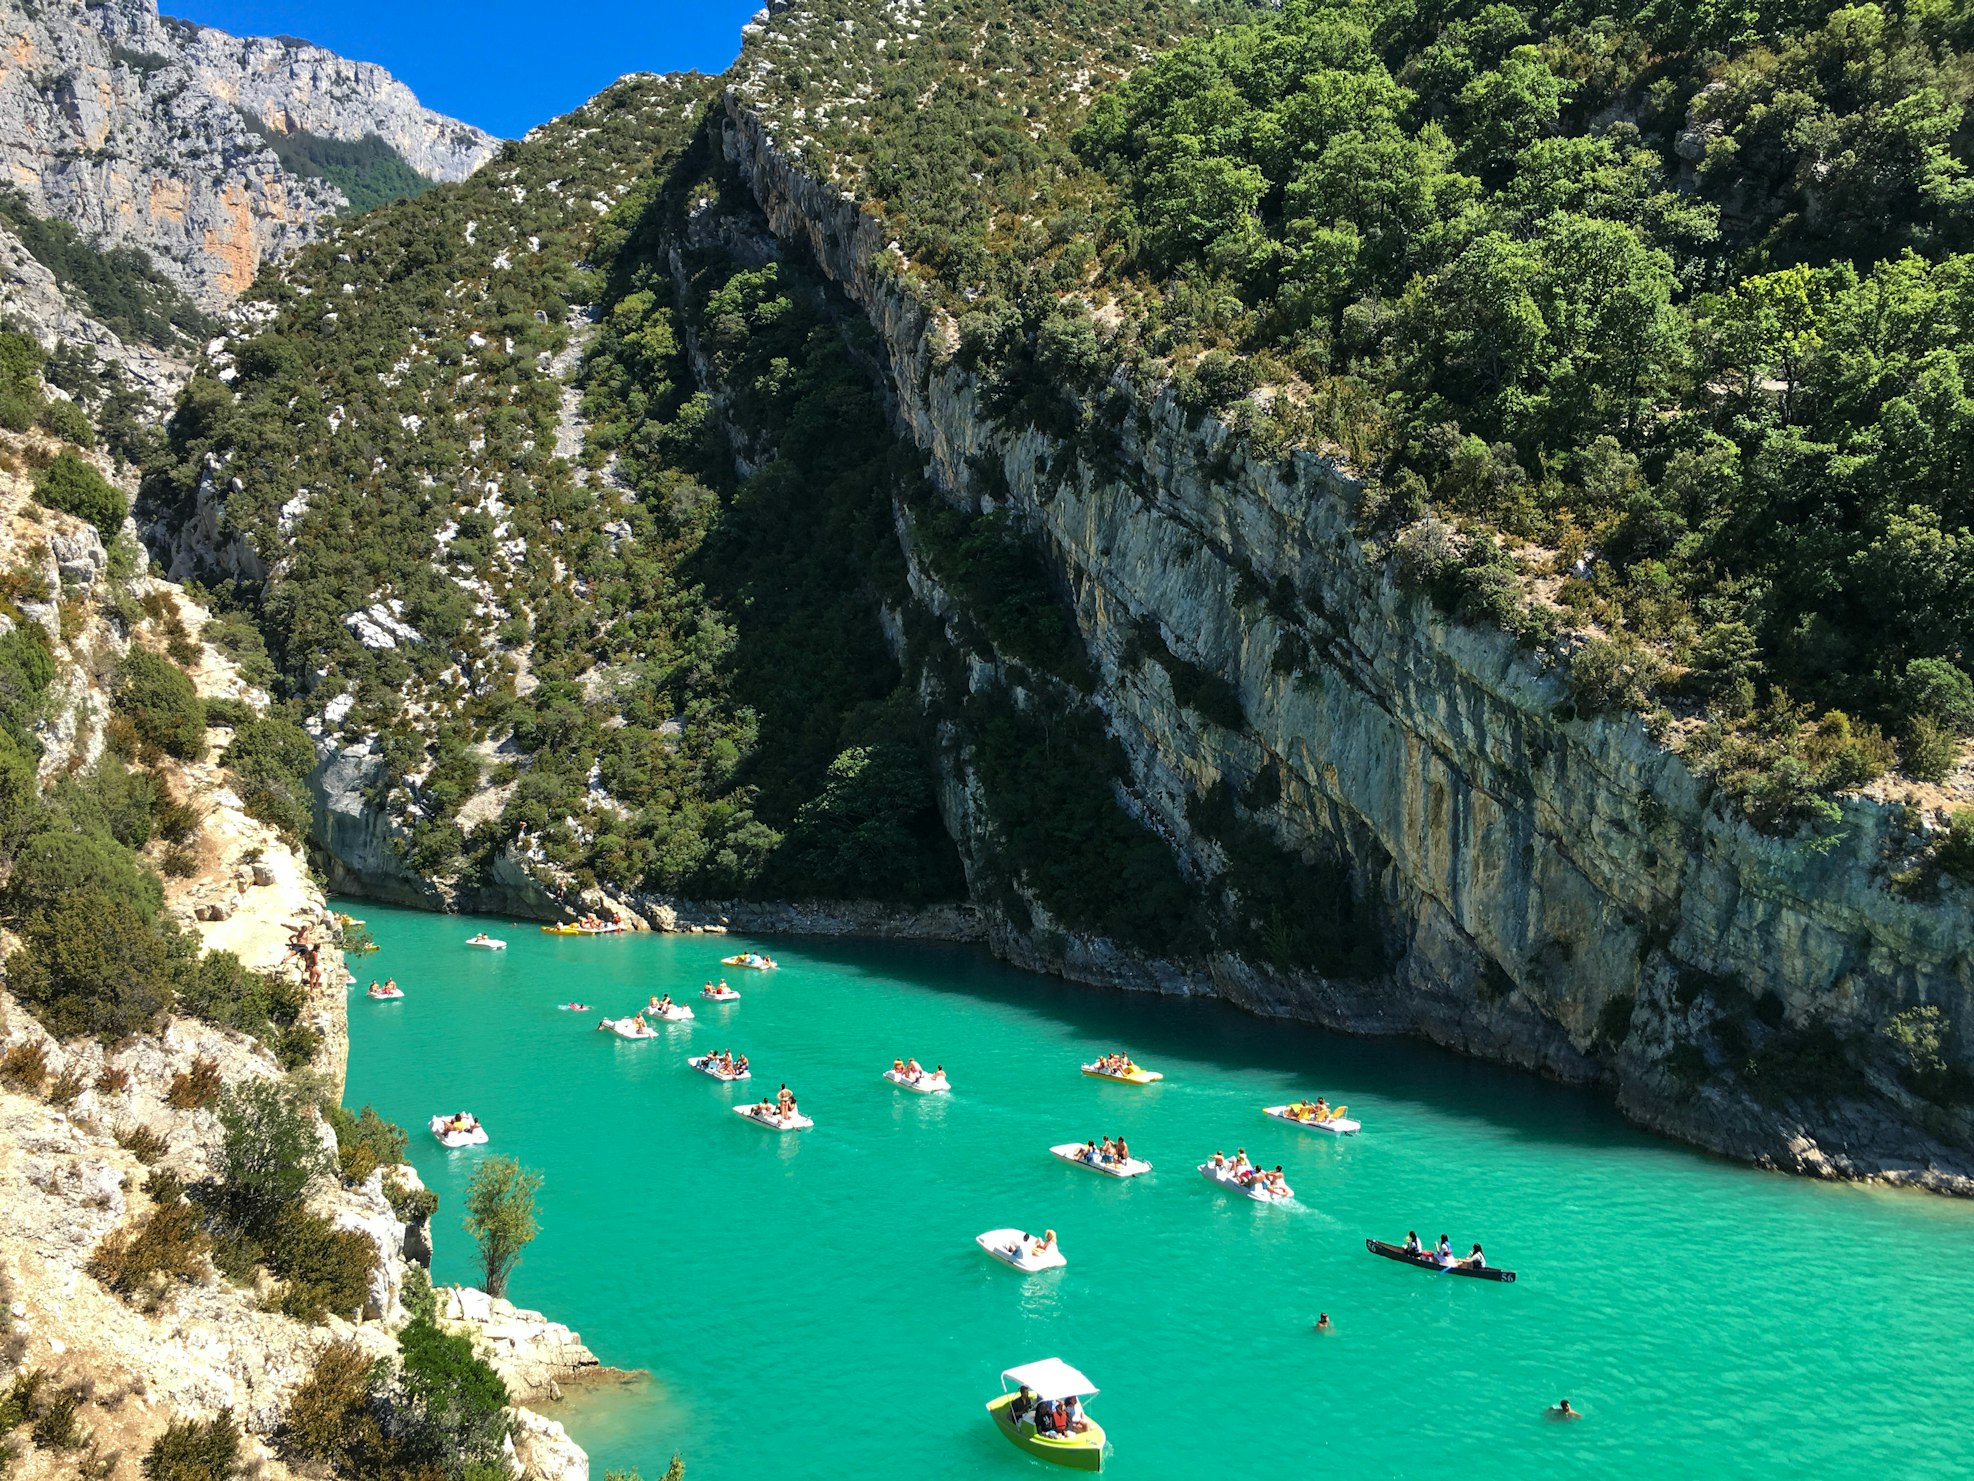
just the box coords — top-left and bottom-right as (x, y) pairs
(347, 904), (1974, 1481)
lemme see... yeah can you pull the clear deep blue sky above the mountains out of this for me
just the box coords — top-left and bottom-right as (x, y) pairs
(179, 0), (762, 138)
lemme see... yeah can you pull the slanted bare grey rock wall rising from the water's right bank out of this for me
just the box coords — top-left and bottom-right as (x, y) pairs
(722, 95), (1974, 1193)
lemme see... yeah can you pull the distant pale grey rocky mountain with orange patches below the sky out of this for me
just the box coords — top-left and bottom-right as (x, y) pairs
(0, 0), (495, 306)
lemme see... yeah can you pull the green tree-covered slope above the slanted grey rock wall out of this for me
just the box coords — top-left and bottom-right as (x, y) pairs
(740, 0), (1974, 829)
